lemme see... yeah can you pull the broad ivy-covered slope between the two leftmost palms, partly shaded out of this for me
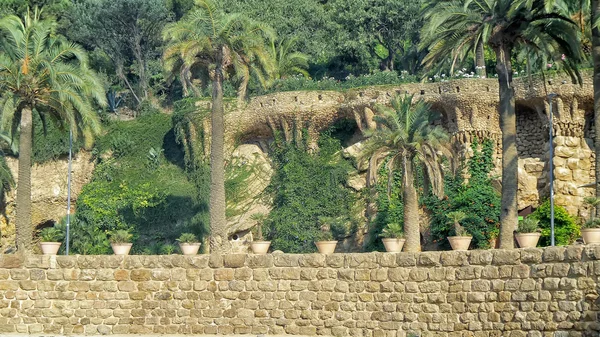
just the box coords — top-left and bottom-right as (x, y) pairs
(72, 113), (207, 254)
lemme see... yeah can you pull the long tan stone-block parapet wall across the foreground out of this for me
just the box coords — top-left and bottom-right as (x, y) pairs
(0, 246), (600, 337)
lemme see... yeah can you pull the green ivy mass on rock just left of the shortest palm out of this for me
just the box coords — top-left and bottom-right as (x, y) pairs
(267, 134), (355, 253)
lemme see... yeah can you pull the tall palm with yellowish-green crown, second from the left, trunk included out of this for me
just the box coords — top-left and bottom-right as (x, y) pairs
(163, 0), (274, 252)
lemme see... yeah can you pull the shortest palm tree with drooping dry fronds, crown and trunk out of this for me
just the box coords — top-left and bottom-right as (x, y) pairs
(360, 96), (448, 252)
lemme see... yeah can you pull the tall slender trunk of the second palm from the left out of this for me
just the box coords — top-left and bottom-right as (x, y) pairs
(210, 53), (227, 253)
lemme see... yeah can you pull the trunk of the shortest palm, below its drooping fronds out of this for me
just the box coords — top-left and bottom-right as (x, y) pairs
(402, 157), (421, 252)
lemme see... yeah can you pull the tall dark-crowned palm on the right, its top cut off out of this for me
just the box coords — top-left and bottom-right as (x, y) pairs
(424, 0), (581, 249)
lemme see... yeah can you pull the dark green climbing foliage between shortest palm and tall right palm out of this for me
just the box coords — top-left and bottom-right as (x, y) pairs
(422, 140), (500, 248)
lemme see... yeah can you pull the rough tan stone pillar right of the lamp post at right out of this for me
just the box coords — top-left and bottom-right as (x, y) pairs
(546, 98), (594, 215)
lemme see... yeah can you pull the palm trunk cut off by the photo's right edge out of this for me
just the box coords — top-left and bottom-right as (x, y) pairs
(592, 0), (600, 217)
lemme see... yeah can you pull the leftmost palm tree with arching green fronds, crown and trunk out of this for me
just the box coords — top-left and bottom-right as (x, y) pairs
(0, 9), (105, 251)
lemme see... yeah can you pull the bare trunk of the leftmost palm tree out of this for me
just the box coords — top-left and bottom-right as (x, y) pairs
(16, 107), (33, 253)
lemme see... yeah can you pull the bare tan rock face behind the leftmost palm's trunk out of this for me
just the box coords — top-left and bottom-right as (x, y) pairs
(0, 151), (94, 247)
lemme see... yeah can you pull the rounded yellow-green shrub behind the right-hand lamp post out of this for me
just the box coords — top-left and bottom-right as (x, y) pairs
(528, 200), (580, 246)
